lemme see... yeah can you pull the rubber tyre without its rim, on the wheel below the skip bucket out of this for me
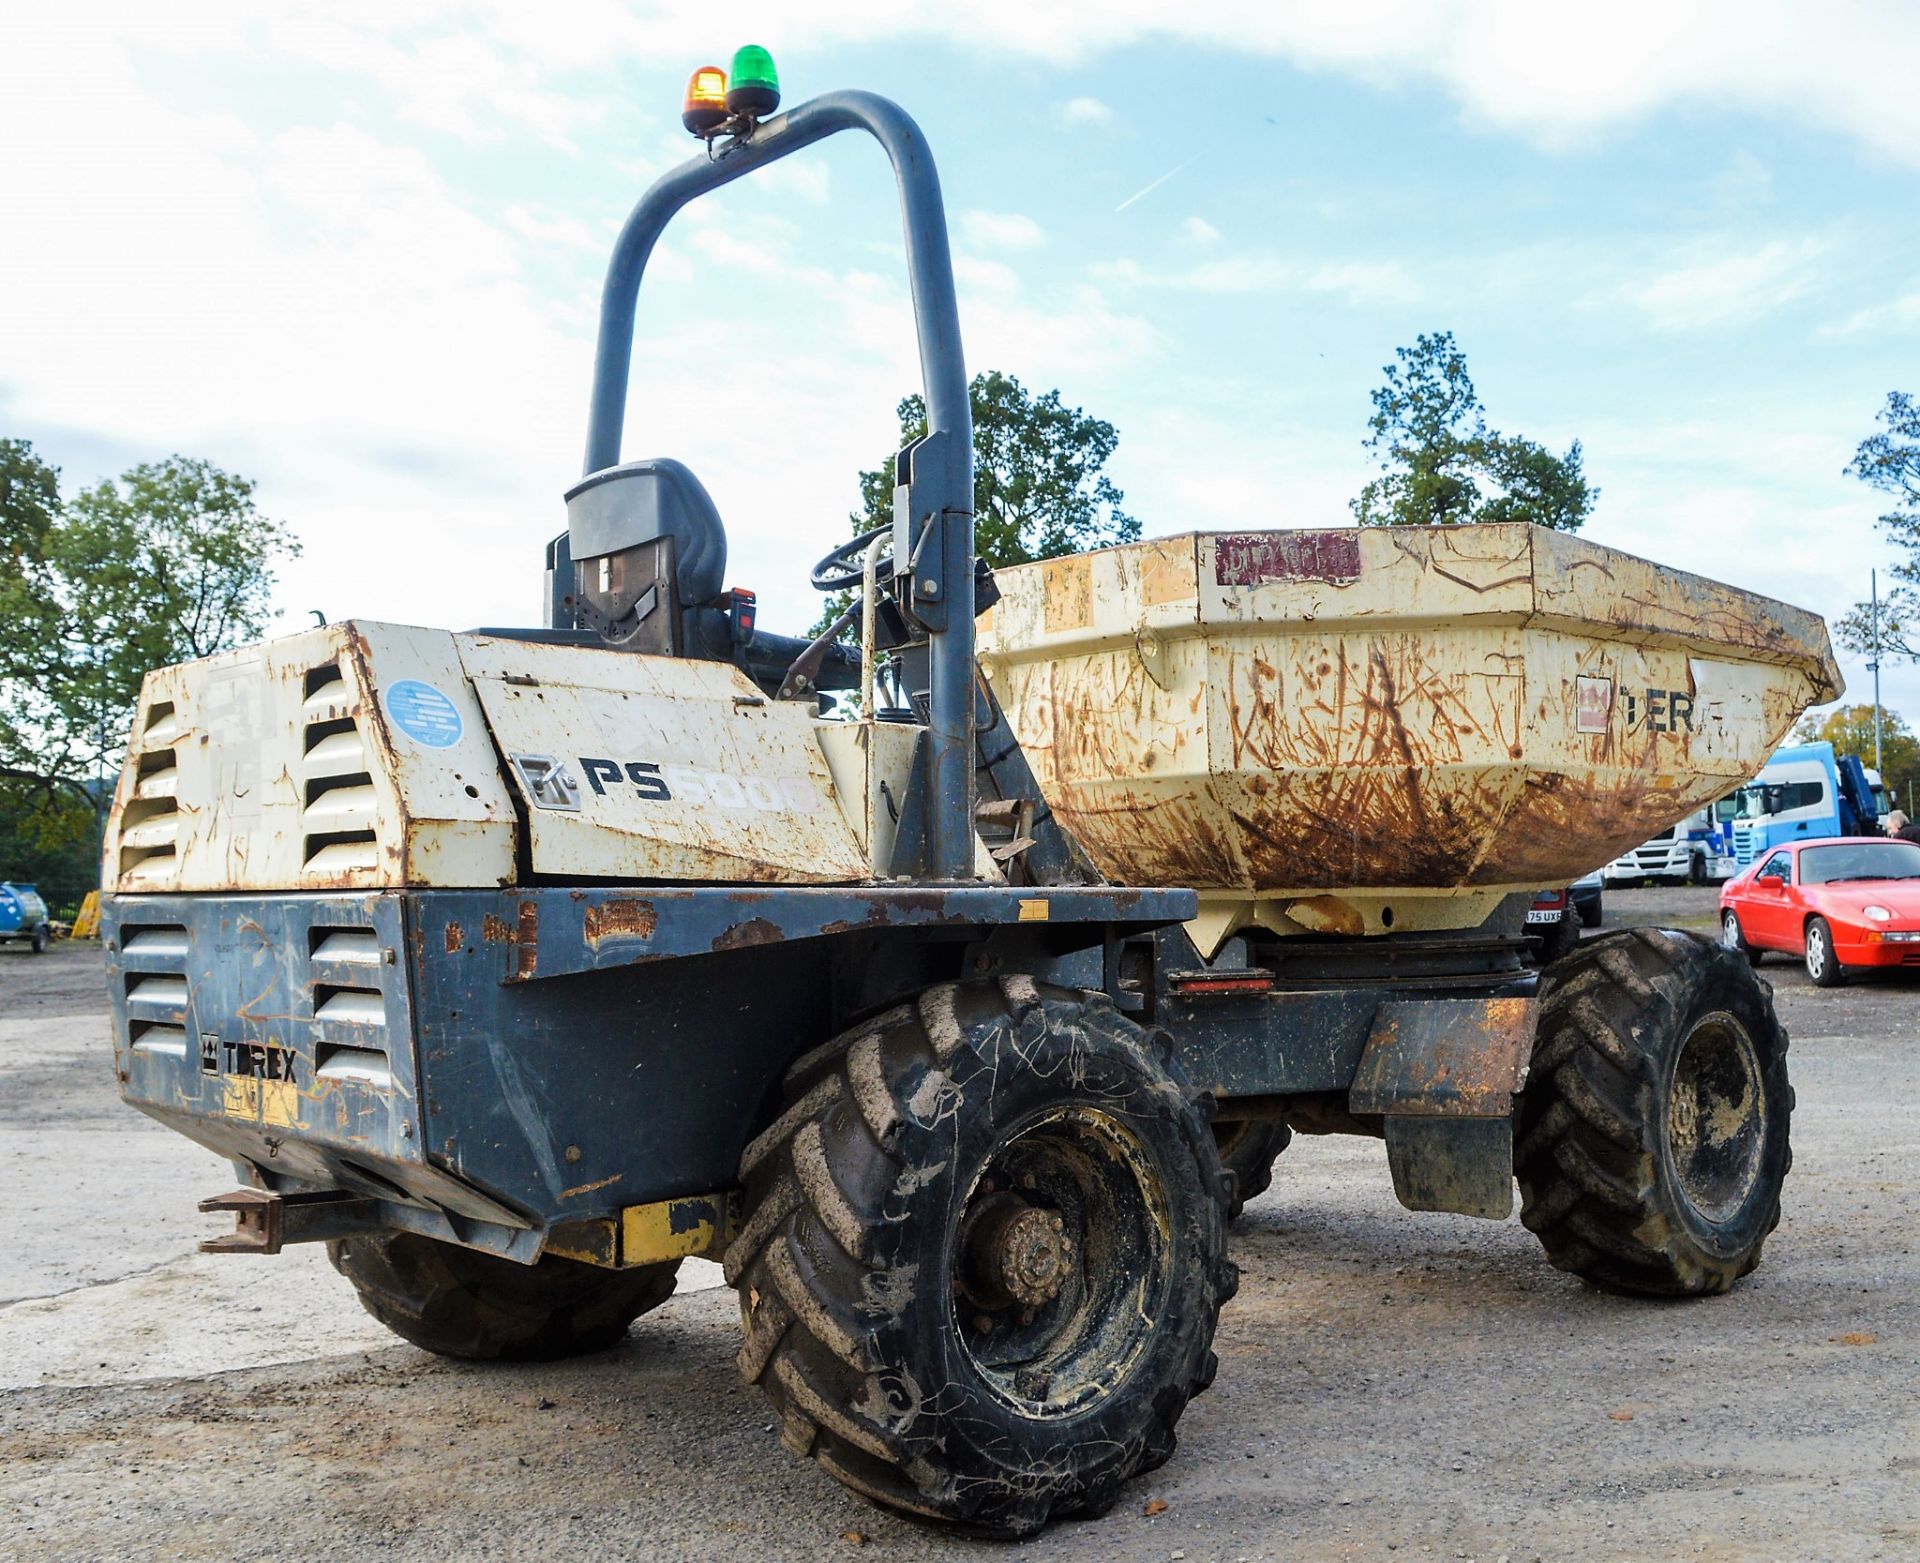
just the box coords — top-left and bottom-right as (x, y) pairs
(1513, 927), (1793, 1296)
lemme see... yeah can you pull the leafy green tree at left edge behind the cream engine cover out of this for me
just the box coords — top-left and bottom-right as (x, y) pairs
(0, 440), (300, 814)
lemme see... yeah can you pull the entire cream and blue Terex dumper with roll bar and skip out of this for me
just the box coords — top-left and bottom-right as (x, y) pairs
(102, 64), (1837, 1536)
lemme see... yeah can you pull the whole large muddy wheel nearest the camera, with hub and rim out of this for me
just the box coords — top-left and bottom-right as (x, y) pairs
(726, 977), (1235, 1536)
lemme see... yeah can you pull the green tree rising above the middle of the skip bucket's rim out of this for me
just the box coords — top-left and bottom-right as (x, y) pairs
(1352, 330), (1599, 532)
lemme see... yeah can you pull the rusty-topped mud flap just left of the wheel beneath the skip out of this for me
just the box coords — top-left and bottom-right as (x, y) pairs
(1348, 997), (1538, 1221)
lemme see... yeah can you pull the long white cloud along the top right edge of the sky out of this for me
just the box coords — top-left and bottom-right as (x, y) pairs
(848, 0), (1920, 165)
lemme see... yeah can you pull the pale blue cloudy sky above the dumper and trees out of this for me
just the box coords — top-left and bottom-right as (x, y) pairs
(0, 0), (1920, 724)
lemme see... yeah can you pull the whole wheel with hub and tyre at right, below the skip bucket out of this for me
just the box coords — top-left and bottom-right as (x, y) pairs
(1513, 927), (1793, 1296)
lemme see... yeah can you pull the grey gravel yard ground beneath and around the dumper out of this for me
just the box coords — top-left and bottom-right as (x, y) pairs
(0, 889), (1920, 1563)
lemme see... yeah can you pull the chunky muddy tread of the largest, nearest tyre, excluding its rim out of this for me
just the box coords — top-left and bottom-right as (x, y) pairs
(724, 977), (1236, 1538)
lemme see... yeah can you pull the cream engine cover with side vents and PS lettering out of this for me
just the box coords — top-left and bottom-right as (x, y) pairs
(104, 622), (960, 893)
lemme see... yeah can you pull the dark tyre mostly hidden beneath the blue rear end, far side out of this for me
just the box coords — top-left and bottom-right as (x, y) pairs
(326, 1233), (680, 1361)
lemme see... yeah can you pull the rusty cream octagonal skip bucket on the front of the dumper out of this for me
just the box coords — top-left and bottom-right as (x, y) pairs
(979, 524), (1841, 952)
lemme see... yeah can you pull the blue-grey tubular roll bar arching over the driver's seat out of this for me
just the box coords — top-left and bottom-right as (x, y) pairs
(582, 92), (973, 879)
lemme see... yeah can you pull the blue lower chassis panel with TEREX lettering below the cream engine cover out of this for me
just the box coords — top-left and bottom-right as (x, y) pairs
(102, 885), (1194, 1227)
